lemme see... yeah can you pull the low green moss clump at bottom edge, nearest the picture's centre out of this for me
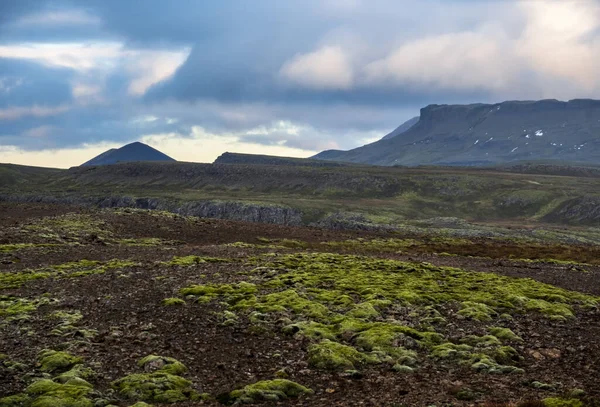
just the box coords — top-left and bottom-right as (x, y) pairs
(229, 379), (314, 404)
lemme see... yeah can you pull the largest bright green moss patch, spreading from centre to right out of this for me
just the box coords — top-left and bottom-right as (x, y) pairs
(180, 253), (598, 373)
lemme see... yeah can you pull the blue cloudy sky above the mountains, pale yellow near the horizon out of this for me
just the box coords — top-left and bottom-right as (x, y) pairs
(0, 0), (600, 168)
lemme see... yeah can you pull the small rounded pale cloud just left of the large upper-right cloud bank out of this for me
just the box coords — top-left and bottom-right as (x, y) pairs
(280, 46), (353, 89)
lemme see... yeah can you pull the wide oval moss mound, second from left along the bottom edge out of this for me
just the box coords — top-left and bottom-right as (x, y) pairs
(112, 372), (195, 403)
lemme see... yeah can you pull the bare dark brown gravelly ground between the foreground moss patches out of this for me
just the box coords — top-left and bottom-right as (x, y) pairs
(0, 203), (600, 407)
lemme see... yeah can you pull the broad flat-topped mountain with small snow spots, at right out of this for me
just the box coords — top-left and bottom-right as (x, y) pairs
(312, 99), (600, 166)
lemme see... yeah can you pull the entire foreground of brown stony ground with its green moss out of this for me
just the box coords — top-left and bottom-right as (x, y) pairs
(0, 203), (600, 407)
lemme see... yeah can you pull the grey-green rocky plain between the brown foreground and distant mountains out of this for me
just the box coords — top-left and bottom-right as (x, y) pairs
(0, 162), (600, 230)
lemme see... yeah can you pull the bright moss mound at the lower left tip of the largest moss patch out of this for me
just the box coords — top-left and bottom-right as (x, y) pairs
(308, 339), (379, 370)
